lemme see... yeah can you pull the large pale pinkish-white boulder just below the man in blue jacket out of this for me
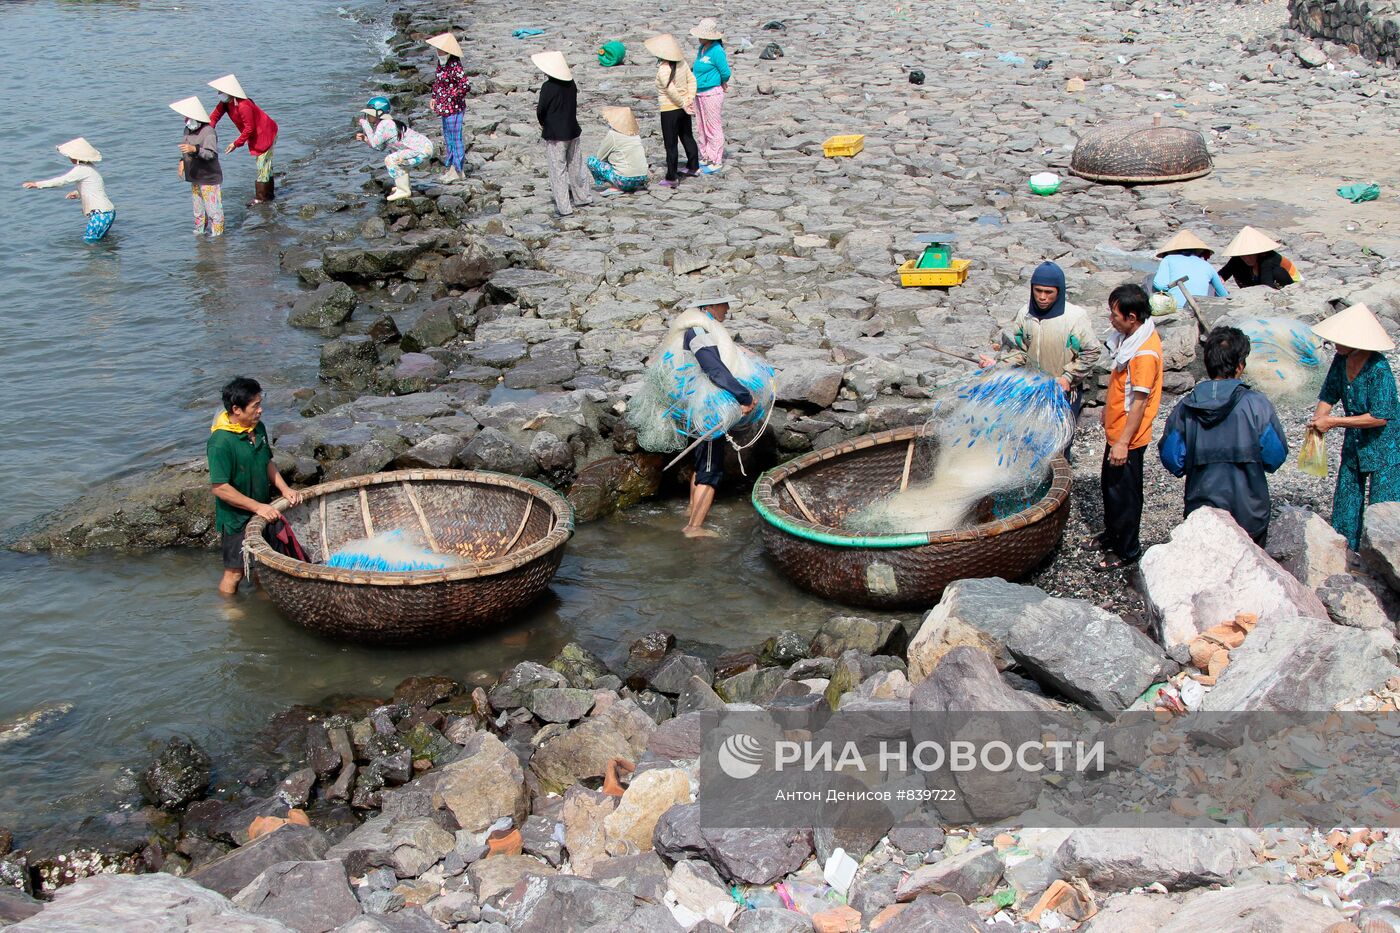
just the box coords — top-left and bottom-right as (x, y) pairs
(1140, 507), (1327, 647)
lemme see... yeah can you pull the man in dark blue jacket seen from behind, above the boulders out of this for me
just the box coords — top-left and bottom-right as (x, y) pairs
(1158, 326), (1288, 545)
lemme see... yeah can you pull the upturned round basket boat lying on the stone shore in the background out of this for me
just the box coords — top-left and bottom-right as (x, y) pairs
(1070, 120), (1211, 185)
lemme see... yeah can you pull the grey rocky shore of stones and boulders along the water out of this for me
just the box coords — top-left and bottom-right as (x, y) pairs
(0, 1), (1400, 933)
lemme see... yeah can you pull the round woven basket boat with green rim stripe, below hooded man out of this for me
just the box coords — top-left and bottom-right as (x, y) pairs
(753, 426), (1070, 609)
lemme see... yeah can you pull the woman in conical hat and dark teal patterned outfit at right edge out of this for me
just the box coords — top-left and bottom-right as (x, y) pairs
(1308, 304), (1400, 551)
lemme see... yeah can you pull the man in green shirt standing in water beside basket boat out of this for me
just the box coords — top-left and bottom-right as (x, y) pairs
(204, 377), (301, 595)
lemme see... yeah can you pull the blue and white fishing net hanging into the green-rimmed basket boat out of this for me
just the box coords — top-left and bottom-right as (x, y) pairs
(843, 368), (1074, 535)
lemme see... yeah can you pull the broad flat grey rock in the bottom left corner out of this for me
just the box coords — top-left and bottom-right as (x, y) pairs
(6, 874), (290, 933)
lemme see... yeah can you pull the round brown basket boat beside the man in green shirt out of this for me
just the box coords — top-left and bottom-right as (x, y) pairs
(244, 469), (574, 644)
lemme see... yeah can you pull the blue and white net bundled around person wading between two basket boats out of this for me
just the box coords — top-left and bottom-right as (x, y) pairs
(627, 347), (773, 454)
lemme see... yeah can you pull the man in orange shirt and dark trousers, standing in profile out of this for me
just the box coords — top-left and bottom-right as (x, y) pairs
(1099, 284), (1162, 570)
